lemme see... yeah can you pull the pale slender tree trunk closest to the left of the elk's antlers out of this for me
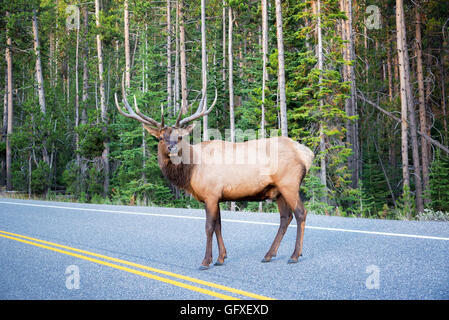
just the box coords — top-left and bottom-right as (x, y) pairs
(95, 0), (109, 196)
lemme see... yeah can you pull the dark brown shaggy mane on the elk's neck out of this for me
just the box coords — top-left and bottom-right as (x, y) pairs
(158, 145), (195, 191)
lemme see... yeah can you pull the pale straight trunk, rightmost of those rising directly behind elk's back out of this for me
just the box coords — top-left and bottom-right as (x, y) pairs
(275, 0), (288, 137)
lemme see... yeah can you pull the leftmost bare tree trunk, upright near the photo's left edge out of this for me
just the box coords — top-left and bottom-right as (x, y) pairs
(5, 12), (13, 191)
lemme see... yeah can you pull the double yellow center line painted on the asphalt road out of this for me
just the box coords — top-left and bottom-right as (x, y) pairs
(0, 230), (271, 300)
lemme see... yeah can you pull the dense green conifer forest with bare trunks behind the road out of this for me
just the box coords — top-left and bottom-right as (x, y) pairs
(0, 0), (449, 220)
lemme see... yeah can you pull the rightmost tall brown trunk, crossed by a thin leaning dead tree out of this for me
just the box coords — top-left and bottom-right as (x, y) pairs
(415, 7), (430, 203)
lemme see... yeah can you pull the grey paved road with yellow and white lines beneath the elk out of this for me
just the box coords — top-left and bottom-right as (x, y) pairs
(0, 199), (449, 300)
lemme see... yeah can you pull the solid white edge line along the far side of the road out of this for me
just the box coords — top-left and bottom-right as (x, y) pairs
(0, 201), (449, 241)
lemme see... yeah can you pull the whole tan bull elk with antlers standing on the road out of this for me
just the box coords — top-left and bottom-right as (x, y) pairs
(115, 84), (314, 270)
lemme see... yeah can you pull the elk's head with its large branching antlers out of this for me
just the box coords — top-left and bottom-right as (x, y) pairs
(115, 79), (217, 157)
